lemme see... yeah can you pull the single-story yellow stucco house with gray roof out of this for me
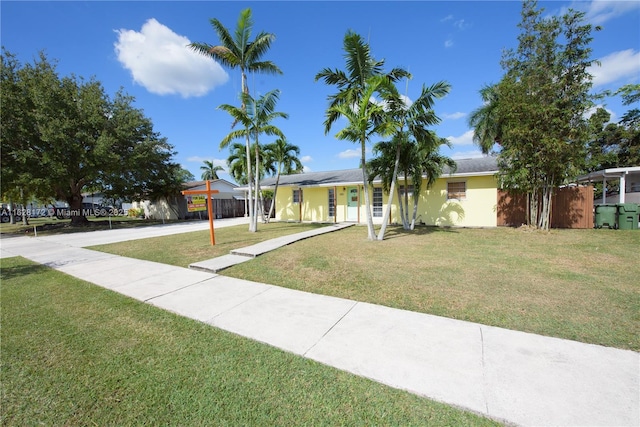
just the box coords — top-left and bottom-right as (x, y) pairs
(255, 157), (498, 227)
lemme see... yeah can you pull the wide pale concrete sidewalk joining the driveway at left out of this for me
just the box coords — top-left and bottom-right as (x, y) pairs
(0, 219), (640, 426)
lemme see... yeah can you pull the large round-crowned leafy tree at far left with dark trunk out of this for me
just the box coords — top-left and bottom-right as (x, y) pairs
(0, 52), (177, 225)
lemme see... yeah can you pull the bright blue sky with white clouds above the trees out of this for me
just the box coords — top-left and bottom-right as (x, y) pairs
(0, 0), (640, 180)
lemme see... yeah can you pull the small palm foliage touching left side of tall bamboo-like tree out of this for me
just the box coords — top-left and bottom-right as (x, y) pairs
(469, 85), (502, 154)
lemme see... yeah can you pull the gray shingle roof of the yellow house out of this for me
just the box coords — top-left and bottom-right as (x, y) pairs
(260, 157), (498, 187)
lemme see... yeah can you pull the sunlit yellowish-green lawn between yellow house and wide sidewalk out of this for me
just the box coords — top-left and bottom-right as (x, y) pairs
(96, 223), (640, 351)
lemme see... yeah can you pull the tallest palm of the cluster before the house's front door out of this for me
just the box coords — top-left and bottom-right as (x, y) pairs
(315, 31), (410, 240)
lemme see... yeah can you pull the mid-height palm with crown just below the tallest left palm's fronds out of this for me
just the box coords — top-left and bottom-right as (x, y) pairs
(218, 89), (289, 231)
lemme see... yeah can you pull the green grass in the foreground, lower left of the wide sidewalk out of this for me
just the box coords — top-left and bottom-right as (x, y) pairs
(0, 258), (497, 426)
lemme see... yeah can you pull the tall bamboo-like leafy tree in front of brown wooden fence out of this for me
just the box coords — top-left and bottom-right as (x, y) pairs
(480, 0), (593, 230)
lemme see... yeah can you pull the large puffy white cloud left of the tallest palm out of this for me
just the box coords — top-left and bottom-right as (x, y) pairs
(114, 18), (229, 98)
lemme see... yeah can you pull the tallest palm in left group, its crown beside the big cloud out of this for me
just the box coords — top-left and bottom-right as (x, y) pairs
(189, 9), (282, 231)
